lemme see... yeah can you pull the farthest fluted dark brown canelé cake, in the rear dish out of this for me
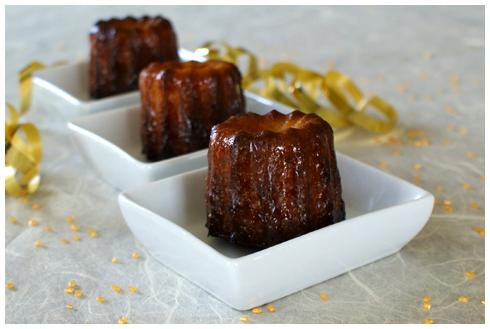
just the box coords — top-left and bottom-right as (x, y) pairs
(89, 16), (179, 98)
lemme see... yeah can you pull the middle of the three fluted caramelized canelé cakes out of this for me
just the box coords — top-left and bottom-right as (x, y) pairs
(139, 60), (245, 160)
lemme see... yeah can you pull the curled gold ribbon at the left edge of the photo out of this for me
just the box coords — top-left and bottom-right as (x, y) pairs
(5, 62), (45, 197)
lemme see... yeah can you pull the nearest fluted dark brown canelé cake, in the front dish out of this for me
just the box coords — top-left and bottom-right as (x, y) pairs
(206, 111), (345, 248)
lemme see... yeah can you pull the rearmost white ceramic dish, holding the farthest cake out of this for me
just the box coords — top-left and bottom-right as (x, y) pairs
(33, 49), (204, 116)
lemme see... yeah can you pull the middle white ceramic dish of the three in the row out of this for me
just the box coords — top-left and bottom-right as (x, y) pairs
(68, 93), (291, 190)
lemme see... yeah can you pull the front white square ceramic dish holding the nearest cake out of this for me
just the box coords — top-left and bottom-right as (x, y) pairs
(119, 154), (434, 310)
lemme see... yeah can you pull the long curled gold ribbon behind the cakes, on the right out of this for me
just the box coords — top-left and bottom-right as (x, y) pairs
(195, 42), (398, 133)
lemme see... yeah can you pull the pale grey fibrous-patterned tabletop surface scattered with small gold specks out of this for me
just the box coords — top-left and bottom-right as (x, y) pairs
(5, 6), (485, 323)
